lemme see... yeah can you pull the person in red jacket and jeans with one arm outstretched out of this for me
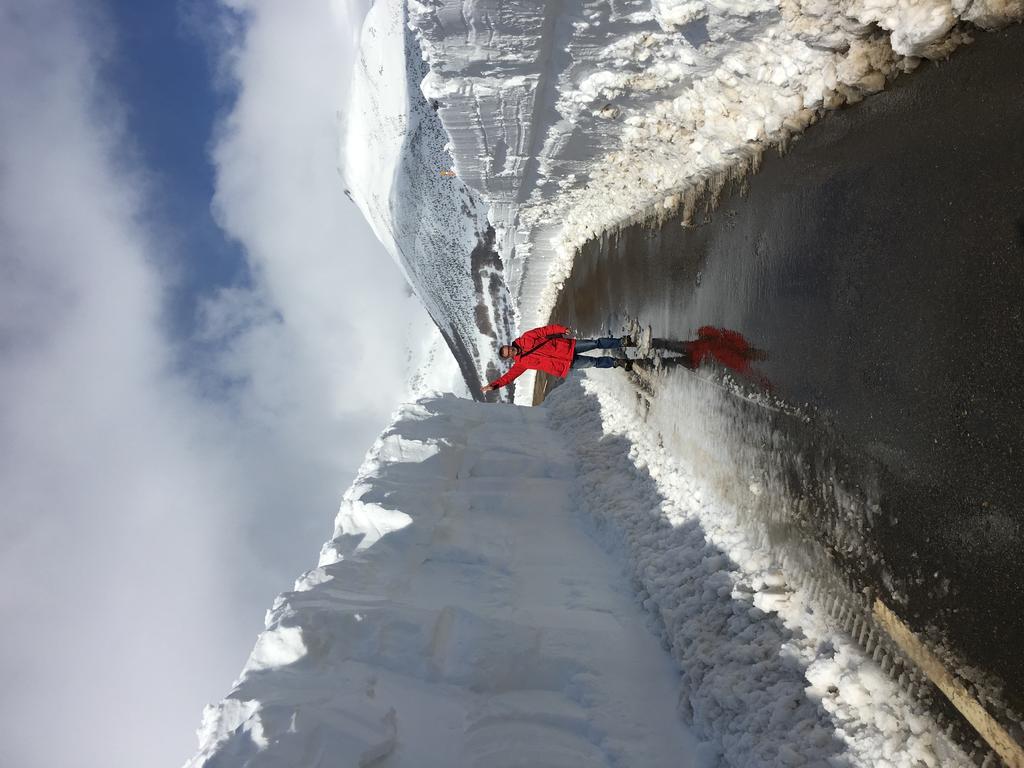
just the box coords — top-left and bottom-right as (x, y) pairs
(480, 325), (636, 392)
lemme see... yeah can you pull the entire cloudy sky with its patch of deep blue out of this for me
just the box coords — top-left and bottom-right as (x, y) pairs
(0, 0), (429, 768)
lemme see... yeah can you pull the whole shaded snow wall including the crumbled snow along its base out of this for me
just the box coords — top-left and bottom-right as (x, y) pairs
(188, 380), (966, 768)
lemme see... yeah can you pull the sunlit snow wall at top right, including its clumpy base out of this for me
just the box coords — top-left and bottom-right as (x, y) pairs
(410, 0), (1024, 328)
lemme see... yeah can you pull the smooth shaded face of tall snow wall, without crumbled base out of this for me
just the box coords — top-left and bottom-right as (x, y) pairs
(187, 395), (696, 768)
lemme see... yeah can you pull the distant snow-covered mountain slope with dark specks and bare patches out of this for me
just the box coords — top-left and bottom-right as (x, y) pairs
(341, 0), (515, 396)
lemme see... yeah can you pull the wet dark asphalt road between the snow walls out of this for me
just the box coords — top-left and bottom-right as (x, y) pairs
(552, 26), (1024, 711)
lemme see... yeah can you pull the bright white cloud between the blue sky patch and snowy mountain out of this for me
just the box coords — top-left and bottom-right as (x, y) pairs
(198, 0), (431, 581)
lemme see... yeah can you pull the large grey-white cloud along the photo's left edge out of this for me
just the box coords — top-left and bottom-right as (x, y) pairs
(0, 3), (251, 768)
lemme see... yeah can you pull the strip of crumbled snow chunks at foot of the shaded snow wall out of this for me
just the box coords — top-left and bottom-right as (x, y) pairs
(546, 374), (971, 768)
